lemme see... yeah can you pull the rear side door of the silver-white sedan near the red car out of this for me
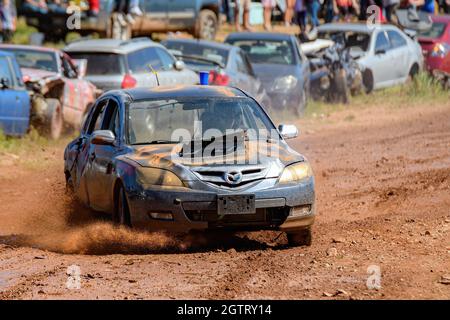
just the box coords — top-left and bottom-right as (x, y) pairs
(387, 30), (411, 81)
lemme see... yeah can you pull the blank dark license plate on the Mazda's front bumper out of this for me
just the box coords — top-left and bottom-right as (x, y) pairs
(217, 194), (256, 215)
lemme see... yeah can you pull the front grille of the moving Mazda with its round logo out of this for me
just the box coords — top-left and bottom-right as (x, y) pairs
(193, 166), (267, 189)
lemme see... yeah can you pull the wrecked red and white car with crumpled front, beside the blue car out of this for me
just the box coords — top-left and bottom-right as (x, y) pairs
(0, 44), (98, 128)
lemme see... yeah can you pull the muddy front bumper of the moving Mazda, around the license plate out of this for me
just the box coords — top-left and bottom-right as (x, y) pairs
(128, 178), (315, 232)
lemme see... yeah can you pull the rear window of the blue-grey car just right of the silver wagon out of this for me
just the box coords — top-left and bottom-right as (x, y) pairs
(165, 41), (229, 67)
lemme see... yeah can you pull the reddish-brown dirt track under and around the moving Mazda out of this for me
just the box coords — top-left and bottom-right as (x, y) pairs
(0, 104), (450, 299)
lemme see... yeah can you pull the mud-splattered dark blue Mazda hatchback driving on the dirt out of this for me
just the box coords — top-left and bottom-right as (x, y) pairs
(64, 86), (315, 244)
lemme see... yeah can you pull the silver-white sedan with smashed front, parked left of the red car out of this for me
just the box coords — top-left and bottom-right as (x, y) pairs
(318, 23), (423, 92)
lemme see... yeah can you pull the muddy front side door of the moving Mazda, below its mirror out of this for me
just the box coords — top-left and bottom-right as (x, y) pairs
(86, 99), (121, 211)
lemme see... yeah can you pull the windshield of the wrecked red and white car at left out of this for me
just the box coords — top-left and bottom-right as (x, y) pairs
(2, 48), (58, 72)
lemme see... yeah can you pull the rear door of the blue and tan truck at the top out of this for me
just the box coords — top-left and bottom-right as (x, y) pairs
(140, 0), (169, 34)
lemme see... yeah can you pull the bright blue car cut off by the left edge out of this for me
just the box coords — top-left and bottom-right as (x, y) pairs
(0, 51), (31, 136)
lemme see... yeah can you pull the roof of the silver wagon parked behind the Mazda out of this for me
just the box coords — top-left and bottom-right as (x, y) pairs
(63, 37), (162, 54)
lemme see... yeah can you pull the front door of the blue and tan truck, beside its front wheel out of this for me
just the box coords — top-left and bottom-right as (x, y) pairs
(165, 0), (197, 30)
